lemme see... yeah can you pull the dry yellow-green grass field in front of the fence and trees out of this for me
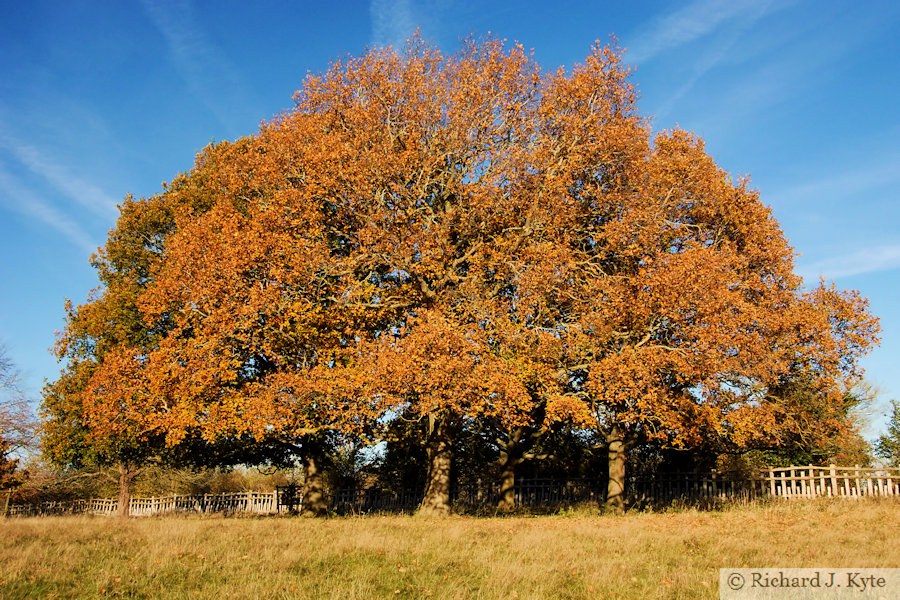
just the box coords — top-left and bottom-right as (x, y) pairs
(0, 500), (900, 600)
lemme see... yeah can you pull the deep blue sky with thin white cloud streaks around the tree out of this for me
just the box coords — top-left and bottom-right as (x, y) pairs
(0, 0), (900, 437)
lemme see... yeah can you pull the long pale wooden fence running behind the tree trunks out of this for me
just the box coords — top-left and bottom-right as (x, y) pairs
(7, 466), (900, 517)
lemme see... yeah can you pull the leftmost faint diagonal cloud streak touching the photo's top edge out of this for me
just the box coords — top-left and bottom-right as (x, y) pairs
(142, 0), (255, 135)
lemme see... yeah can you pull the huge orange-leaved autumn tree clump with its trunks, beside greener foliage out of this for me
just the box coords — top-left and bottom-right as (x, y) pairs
(56, 39), (877, 515)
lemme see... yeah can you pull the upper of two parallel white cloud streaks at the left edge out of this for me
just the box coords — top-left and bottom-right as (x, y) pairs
(0, 130), (118, 219)
